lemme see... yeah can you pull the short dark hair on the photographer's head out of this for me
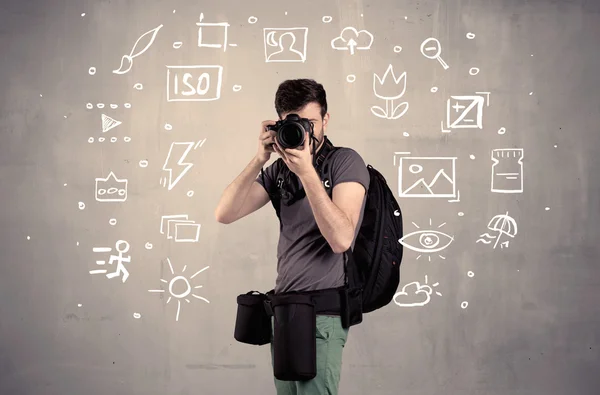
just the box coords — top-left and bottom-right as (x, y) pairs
(275, 78), (327, 119)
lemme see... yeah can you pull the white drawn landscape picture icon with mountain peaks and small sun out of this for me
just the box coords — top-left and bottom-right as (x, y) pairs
(394, 153), (460, 202)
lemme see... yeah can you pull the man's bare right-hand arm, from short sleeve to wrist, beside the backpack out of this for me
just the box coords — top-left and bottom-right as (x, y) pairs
(300, 169), (365, 254)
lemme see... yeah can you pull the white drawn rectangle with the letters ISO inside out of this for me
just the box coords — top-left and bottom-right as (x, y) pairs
(167, 65), (223, 102)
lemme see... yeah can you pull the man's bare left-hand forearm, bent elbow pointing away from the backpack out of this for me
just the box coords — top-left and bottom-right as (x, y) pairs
(215, 157), (269, 224)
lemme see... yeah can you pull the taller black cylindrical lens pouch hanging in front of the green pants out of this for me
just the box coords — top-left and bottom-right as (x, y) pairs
(270, 293), (317, 381)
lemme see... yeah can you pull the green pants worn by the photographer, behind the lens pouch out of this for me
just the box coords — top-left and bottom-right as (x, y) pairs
(271, 315), (348, 395)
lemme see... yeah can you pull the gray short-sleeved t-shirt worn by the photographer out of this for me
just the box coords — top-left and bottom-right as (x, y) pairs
(256, 148), (370, 293)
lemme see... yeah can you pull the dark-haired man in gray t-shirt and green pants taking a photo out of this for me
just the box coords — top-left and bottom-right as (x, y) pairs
(215, 79), (370, 395)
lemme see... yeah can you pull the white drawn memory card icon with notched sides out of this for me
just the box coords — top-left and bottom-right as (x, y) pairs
(492, 148), (523, 193)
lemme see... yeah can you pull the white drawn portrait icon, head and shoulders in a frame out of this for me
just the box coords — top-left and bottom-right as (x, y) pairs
(263, 27), (308, 63)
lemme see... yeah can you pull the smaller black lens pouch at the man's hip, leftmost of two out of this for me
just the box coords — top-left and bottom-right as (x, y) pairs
(233, 291), (271, 346)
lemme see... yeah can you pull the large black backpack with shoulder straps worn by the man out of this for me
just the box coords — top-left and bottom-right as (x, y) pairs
(269, 137), (403, 313)
